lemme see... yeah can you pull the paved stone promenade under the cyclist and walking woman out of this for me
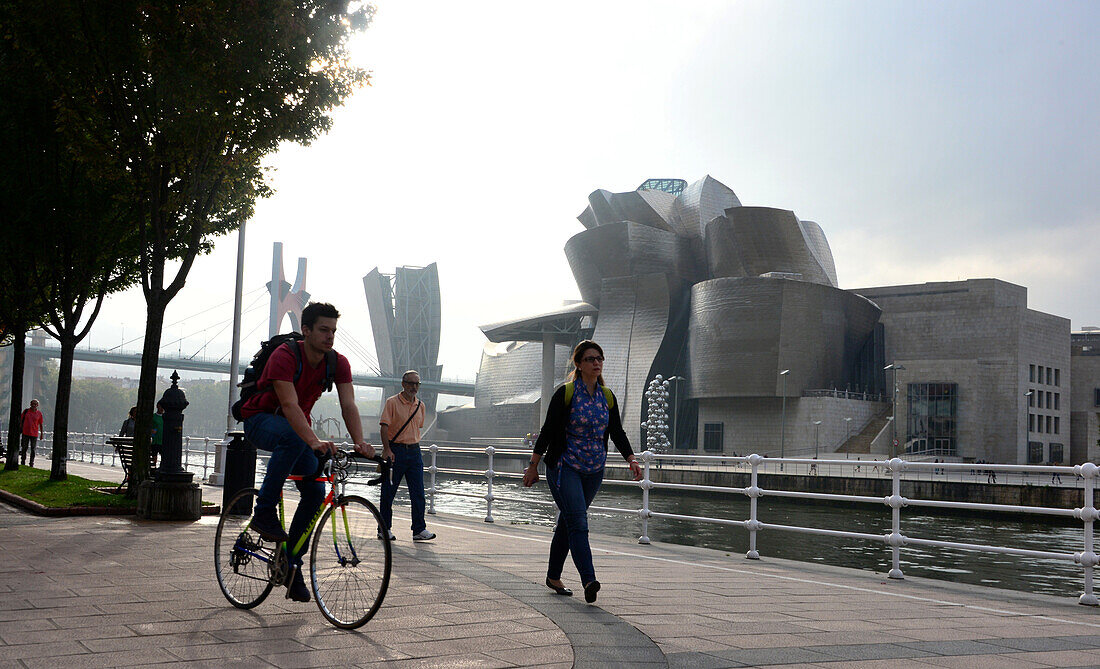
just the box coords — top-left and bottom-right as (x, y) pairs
(0, 463), (1100, 669)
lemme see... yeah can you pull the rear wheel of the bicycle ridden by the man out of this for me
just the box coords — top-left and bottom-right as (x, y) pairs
(213, 489), (278, 608)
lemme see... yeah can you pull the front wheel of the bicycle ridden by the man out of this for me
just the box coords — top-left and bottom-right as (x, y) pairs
(309, 495), (391, 629)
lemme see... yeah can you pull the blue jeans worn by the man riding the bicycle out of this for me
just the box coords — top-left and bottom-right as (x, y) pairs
(244, 414), (325, 566)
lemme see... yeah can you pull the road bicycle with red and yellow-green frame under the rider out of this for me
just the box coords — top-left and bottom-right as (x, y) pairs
(213, 450), (391, 629)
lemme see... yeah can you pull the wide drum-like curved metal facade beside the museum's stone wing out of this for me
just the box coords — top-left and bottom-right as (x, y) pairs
(688, 277), (881, 398)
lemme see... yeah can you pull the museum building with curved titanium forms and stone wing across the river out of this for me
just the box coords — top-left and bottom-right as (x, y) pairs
(441, 176), (1082, 463)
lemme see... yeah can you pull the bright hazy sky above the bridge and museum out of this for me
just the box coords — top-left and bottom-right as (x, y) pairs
(77, 0), (1100, 379)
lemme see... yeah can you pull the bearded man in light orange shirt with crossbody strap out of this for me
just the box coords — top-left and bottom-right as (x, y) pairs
(378, 370), (436, 541)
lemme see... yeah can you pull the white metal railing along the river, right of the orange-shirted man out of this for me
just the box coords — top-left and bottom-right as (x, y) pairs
(415, 440), (1100, 606)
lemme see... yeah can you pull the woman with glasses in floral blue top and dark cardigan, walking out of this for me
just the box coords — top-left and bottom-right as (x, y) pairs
(524, 340), (641, 603)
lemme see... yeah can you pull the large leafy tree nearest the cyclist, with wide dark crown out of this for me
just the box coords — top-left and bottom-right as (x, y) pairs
(2, 0), (374, 490)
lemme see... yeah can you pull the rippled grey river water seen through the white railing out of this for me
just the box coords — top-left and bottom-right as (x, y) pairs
(349, 478), (1084, 596)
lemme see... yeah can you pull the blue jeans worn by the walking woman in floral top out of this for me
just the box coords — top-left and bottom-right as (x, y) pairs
(547, 462), (604, 584)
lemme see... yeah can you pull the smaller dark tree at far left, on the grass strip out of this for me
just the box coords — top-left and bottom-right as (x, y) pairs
(0, 7), (138, 481)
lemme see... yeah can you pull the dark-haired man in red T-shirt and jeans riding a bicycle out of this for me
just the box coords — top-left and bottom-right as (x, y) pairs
(241, 303), (374, 602)
